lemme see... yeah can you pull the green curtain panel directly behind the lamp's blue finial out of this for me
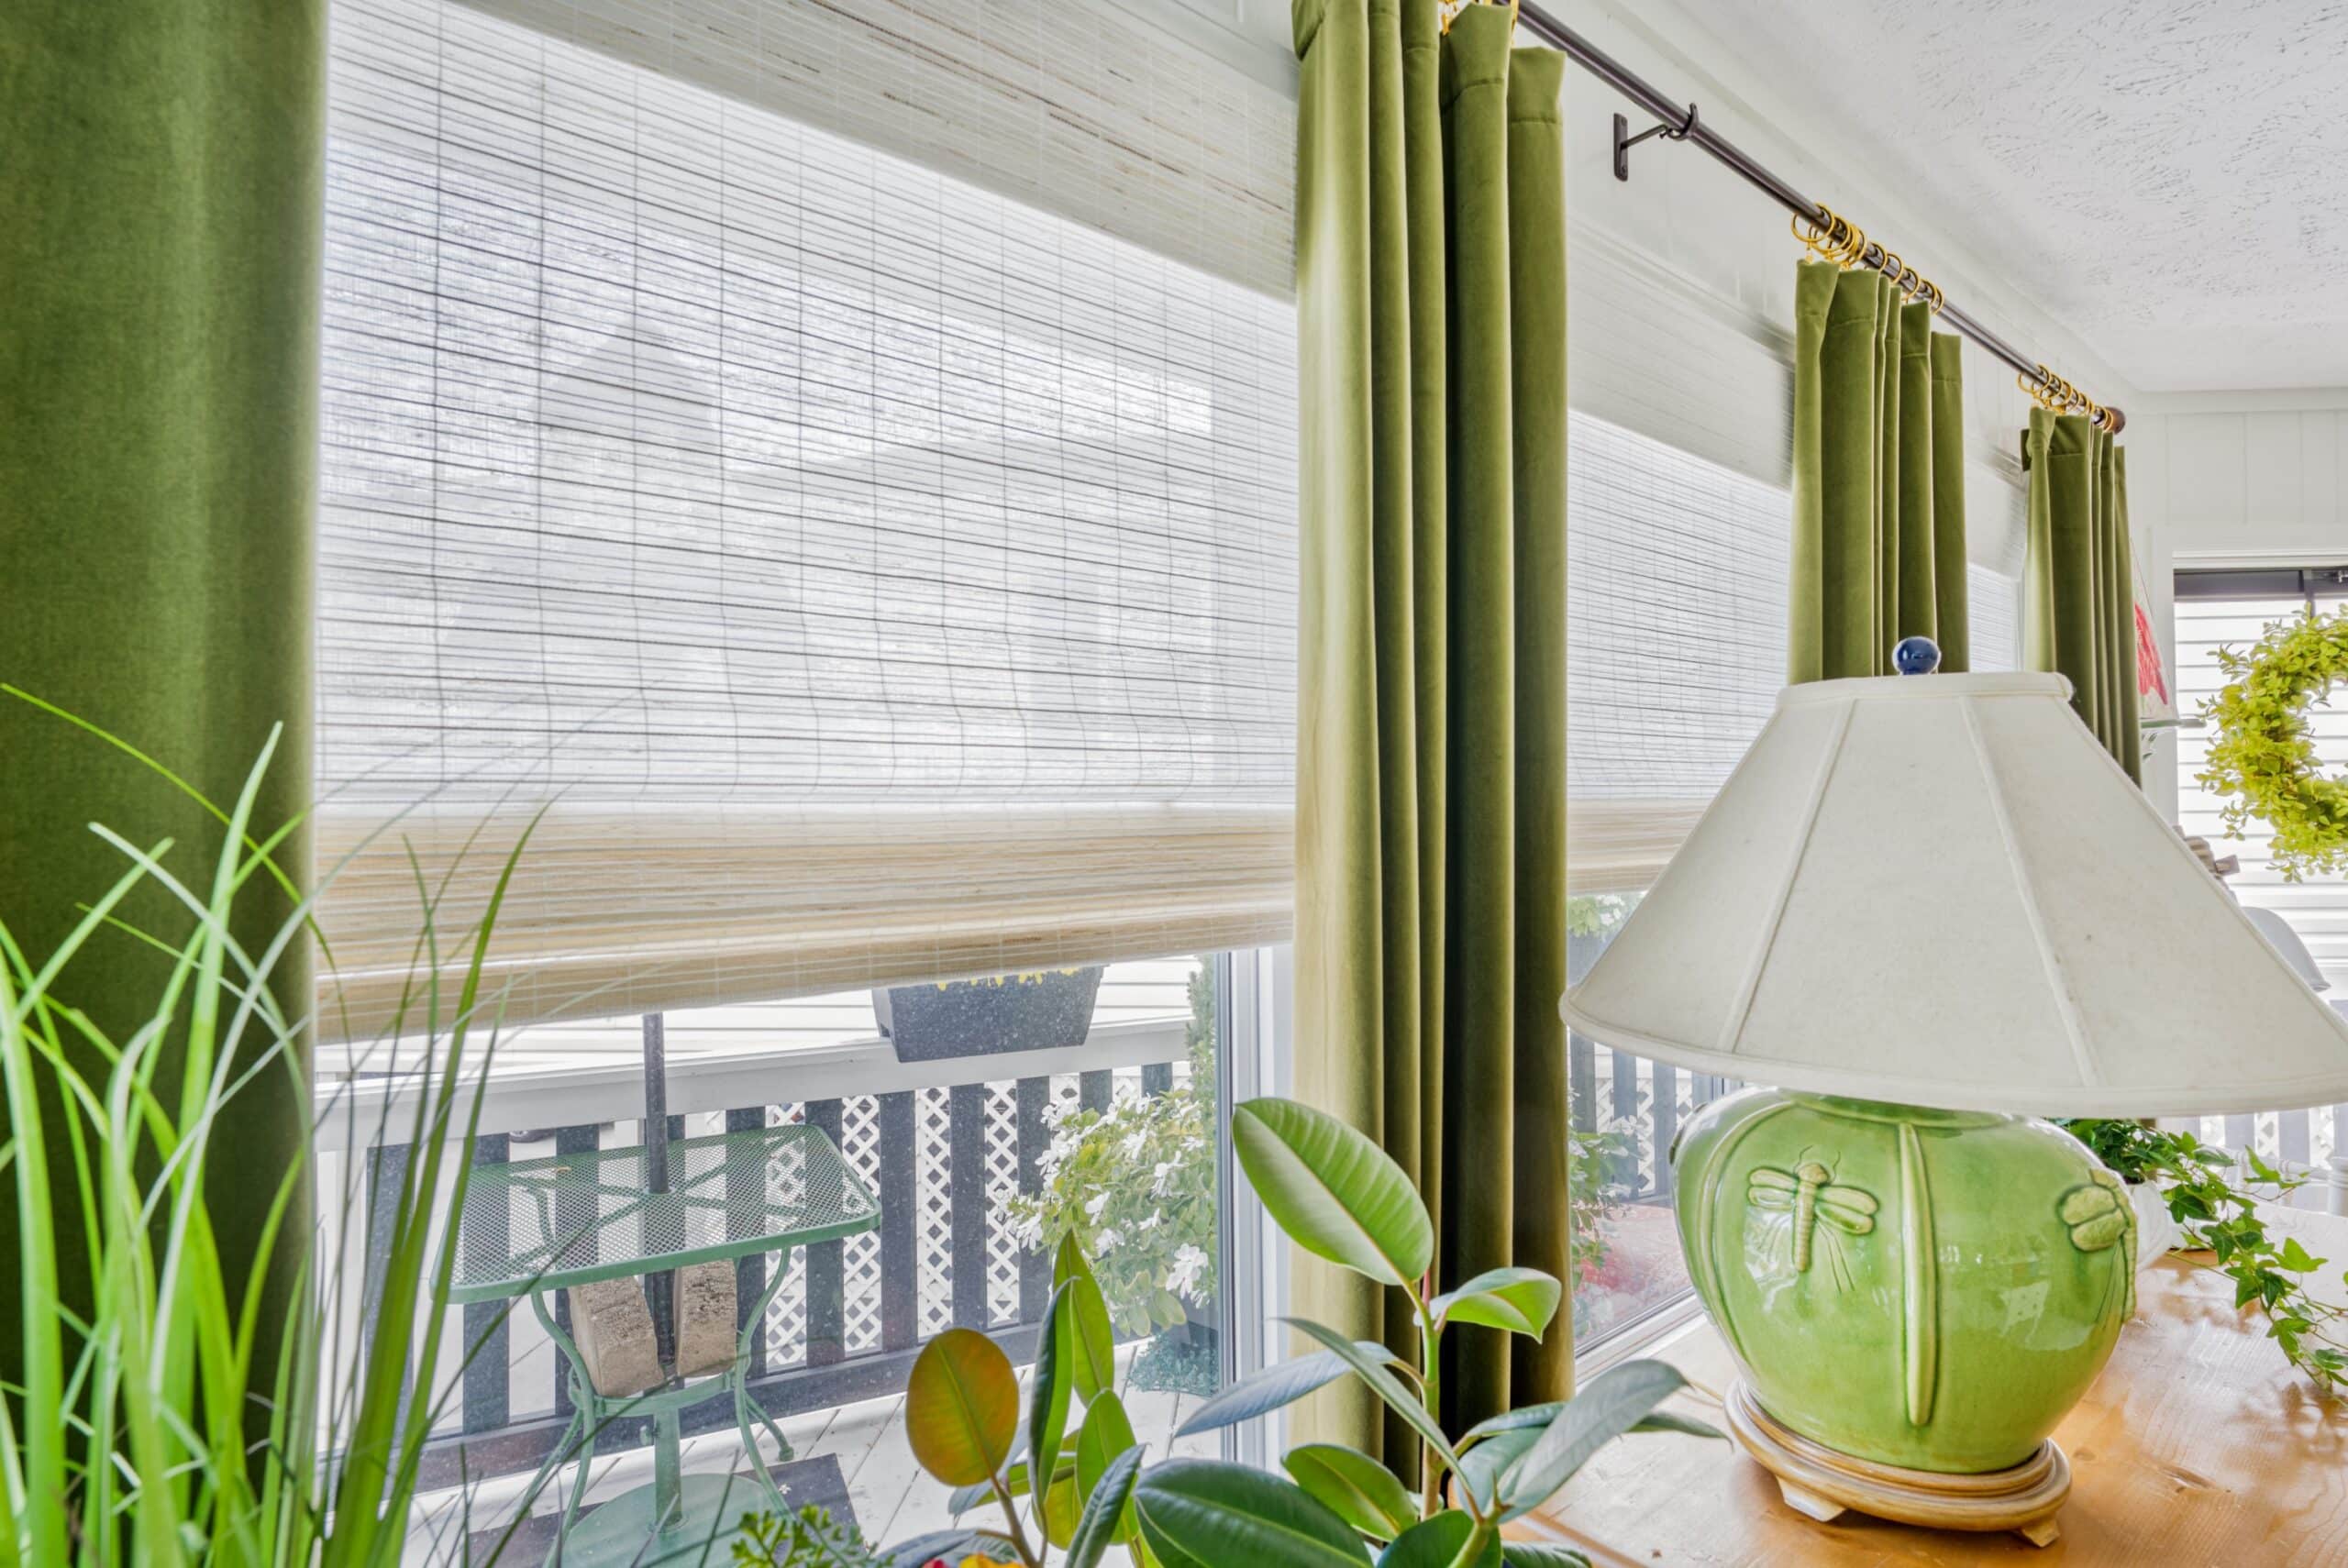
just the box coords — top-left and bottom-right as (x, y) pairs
(1787, 260), (1972, 683)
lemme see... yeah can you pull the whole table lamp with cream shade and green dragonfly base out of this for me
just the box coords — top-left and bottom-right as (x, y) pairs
(1564, 638), (2348, 1544)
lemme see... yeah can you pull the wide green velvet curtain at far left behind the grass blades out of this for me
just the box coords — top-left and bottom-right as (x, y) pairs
(0, 0), (327, 1416)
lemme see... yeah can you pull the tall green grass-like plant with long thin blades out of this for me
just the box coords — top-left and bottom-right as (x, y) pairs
(0, 713), (528, 1568)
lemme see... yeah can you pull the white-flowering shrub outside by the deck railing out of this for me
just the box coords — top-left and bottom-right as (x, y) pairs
(1007, 967), (1216, 1336)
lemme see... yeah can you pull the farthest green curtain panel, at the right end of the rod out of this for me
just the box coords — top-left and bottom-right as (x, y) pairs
(2021, 408), (2143, 784)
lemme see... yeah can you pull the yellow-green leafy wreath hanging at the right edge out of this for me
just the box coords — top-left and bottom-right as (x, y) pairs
(2198, 611), (2348, 883)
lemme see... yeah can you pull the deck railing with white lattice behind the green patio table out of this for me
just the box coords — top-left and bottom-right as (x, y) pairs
(317, 1016), (1188, 1485)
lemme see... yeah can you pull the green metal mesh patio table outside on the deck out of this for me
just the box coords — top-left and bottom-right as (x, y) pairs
(449, 1124), (880, 1568)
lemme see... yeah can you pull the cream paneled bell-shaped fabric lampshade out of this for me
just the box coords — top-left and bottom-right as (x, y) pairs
(1564, 674), (2348, 1118)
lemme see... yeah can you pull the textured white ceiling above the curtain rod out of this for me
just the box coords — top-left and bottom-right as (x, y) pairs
(1686, 0), (2348, 392)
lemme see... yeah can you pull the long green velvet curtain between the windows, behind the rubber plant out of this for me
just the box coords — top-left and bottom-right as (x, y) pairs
(1294, 0), (1573, 1469)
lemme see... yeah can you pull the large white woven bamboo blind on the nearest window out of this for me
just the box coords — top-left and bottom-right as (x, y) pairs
(319, 0), (1296, 1035)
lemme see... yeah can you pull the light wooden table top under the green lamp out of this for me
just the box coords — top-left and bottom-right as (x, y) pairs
(1519, 1211), (2348, 1568)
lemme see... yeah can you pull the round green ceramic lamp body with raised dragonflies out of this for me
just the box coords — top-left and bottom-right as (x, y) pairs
(1674, 1089), (2137, 1520)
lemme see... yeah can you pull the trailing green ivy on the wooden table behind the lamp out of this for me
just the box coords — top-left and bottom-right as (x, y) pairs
(2062, 1118), (2348, 1389)
